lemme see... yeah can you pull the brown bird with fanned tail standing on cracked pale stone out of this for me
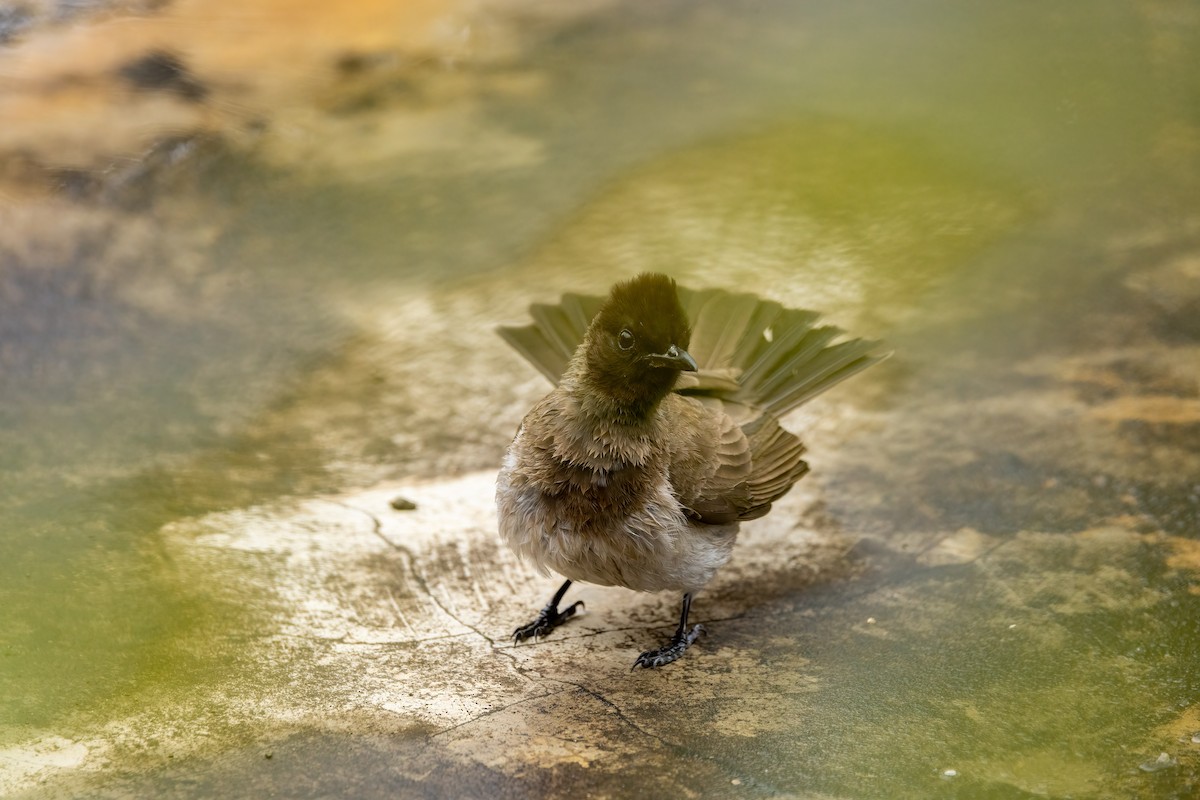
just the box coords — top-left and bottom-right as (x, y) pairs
(496, 272), (889, 669)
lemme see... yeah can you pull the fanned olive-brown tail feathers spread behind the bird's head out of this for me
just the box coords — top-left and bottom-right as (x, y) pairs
(499, 281), (890, 417)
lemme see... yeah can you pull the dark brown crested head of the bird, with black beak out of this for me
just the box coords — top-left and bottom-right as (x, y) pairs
(583, 272), (696, 416)
